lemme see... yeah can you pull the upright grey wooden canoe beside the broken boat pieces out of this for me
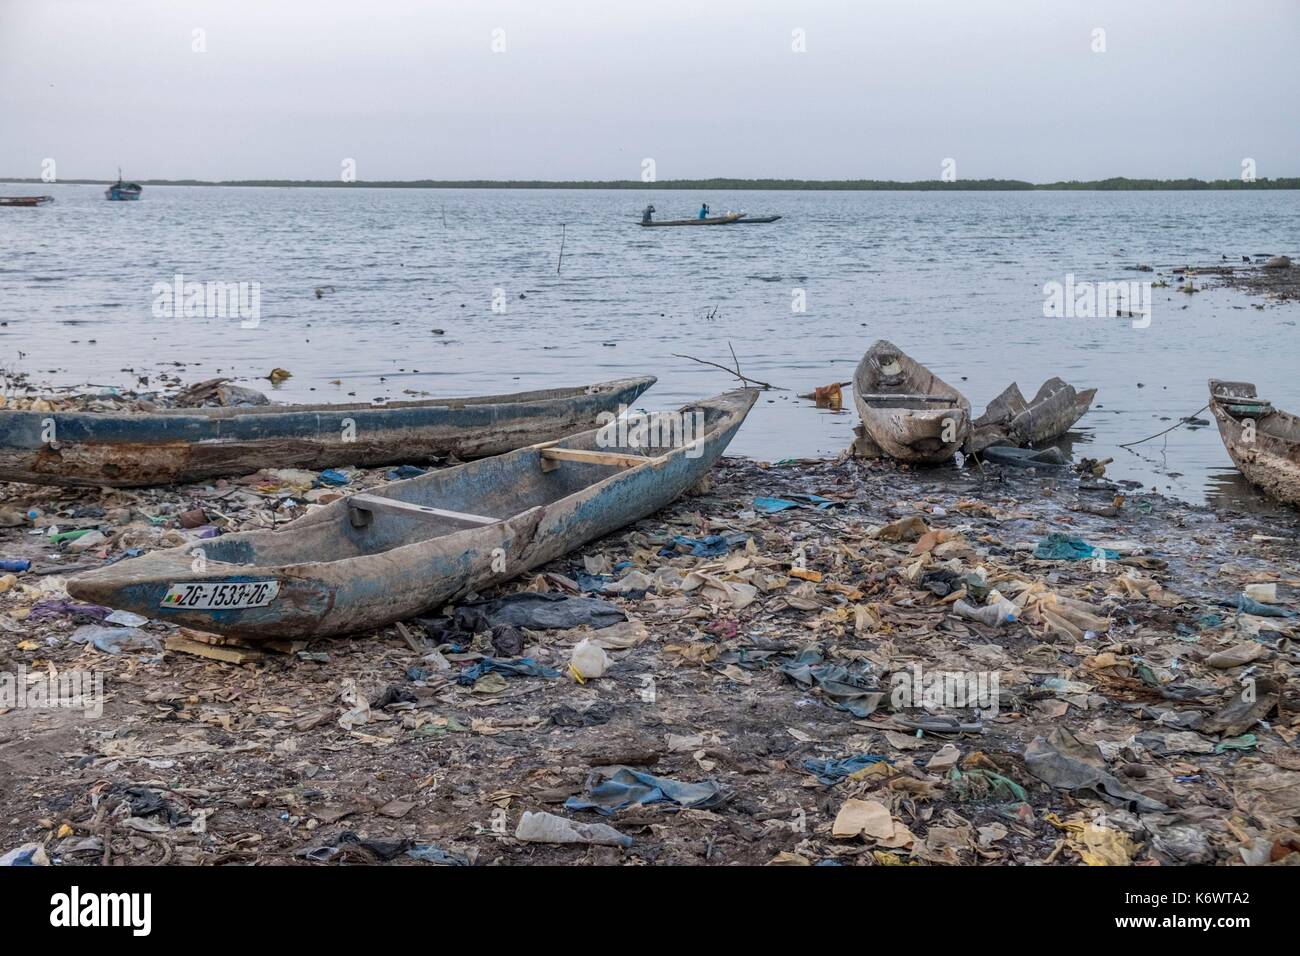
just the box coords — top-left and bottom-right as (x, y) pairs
(853, 339), (971, 464)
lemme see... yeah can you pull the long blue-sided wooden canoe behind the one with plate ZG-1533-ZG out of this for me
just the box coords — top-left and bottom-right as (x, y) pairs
(0, 376), (655, 488)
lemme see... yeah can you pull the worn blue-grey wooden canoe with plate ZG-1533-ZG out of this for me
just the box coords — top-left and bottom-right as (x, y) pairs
(68, 389), (758, 640)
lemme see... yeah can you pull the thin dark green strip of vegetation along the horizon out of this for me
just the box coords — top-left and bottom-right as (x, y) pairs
(5, 176), (1300, 193)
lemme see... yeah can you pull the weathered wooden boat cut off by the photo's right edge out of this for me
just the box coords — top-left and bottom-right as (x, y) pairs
(1210, 378), (1300, 505)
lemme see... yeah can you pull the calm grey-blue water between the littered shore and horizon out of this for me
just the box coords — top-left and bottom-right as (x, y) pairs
(0, 185), (1300, 501)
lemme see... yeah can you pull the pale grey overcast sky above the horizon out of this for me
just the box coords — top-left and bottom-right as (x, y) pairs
(0, 0), (1300, 182)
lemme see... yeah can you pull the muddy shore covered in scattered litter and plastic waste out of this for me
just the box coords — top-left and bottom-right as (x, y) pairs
(0, 458), (1300, 865)
